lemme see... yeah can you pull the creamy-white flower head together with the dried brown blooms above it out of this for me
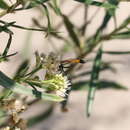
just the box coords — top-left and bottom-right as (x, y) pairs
(41, 53), (71, 97)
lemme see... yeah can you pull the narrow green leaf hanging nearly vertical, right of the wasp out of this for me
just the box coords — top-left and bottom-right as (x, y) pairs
(87, 47), (102, 116)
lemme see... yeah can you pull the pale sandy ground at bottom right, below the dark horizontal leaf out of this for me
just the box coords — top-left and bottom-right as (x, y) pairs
(30, 90), (130, 130)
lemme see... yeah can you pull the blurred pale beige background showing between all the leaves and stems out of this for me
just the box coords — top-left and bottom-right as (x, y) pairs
(0, 0), (130, 130)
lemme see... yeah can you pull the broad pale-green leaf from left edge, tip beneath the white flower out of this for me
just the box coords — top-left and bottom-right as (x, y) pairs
(0, 71), (64, 102)
